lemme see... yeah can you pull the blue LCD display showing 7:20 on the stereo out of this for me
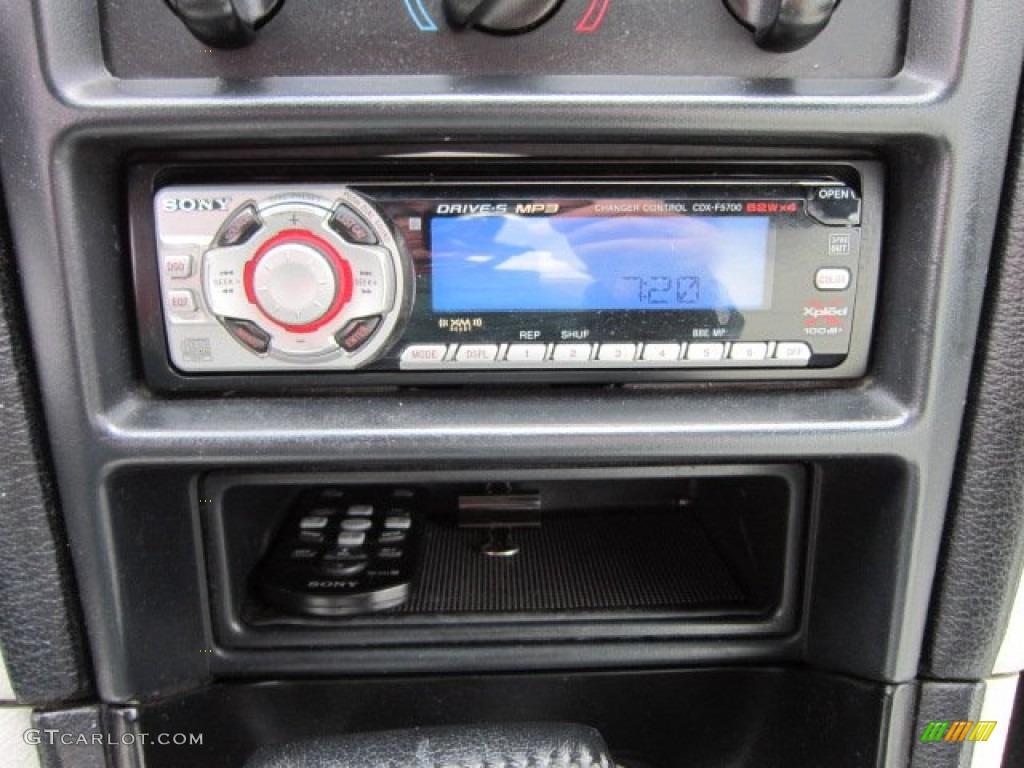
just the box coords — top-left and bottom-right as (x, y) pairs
(430, 215), (770, 312)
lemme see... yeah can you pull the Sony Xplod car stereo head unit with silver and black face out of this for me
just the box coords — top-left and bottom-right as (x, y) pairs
(134, 163), (882, 387)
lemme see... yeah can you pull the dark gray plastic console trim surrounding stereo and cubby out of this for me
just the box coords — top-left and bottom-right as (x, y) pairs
(0, 0), (1024, 700)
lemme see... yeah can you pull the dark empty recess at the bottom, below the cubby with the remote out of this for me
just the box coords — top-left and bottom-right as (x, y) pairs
(130, 667), (916, 768)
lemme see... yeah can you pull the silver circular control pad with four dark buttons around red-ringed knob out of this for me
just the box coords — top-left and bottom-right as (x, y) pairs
(197, 192), (412, 371)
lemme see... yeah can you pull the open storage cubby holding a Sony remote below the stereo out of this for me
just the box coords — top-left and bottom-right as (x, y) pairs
(201, 466), (805, 647)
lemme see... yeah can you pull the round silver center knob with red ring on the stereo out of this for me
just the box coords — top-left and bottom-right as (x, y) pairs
(245, 229), (352, 333)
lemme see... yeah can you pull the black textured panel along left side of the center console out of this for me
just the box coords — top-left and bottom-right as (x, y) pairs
(0, 189), (89, 703)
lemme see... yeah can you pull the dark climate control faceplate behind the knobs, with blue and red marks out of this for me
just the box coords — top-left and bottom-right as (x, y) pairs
(99, 0), (905, 82)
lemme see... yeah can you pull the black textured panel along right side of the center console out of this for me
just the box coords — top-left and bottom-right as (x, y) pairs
(922, 90), (1024, 680)
